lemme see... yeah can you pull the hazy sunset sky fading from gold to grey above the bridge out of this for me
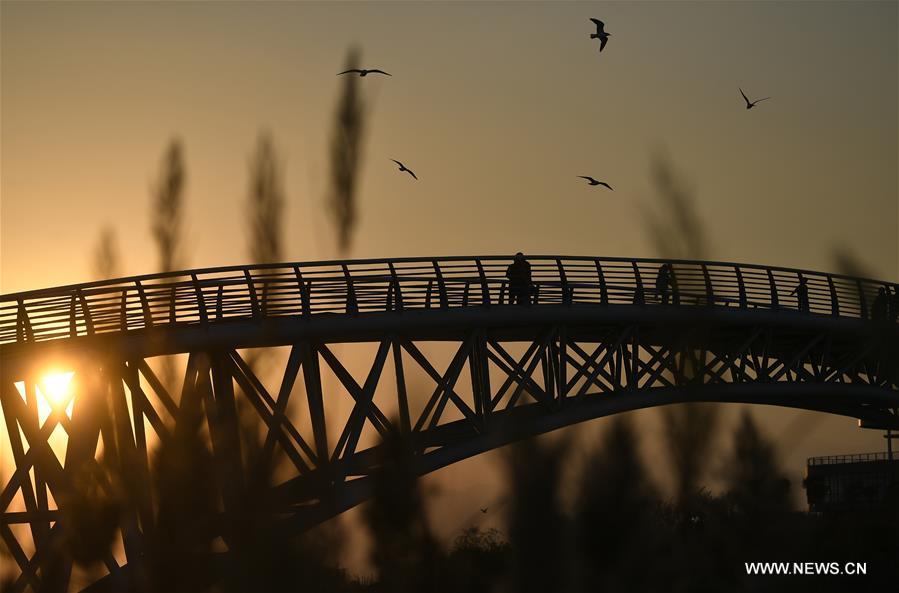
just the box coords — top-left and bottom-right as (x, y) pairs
(0, 1), (899, 572)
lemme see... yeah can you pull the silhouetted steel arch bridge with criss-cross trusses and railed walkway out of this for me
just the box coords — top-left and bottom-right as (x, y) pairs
(0, 256), (899, 591)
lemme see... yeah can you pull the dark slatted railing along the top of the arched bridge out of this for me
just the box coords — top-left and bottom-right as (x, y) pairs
(0, 256), (896, 344)
